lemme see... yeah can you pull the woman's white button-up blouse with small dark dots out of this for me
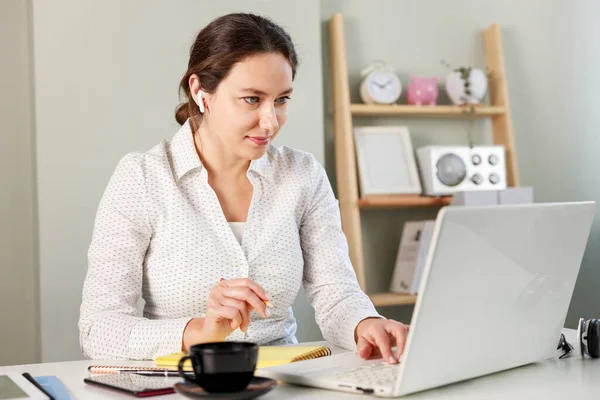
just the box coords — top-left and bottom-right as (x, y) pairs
(79, 121), (379, 359)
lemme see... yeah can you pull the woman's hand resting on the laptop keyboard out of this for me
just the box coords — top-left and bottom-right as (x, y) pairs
(355, 318), (409, 364)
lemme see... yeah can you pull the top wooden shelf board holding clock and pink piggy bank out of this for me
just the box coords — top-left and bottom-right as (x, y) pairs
(350, 104), (505, 119)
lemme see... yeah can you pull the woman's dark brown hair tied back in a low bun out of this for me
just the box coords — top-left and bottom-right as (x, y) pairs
(175, 13), (298, 125)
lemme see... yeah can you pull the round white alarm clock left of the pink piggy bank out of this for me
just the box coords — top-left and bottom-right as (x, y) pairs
(360, 63), (402, 104)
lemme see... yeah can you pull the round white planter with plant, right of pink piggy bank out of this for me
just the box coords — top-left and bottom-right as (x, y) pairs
(442, 60), (488, 105)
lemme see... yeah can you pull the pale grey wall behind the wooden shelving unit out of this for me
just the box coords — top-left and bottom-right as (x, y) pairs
(321, 0), (600, 327)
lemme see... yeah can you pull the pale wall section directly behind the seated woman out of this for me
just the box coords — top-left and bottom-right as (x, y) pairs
(33, 0), (324, 361)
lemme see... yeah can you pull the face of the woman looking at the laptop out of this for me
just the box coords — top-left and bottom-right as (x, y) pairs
(192, 53), (292, 160)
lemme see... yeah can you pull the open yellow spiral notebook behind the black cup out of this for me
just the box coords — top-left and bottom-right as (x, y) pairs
(154, 346), (331, 369)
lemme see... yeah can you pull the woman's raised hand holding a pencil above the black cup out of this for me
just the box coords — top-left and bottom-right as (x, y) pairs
(182, 278), (270, 351)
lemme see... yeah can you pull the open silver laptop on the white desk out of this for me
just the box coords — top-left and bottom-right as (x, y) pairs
(260, 202), (596, 397)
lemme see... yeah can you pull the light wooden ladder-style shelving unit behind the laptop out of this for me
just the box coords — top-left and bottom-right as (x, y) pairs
(329, 13), (519, 306)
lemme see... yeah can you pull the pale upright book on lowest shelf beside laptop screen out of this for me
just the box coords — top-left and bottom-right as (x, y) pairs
(390, 220), (435, 295)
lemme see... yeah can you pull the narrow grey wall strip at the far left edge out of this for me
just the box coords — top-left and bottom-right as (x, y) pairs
(0, 0), (39, 365)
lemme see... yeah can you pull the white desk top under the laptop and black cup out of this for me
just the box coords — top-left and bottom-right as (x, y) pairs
(0, 329), (600, 400)
